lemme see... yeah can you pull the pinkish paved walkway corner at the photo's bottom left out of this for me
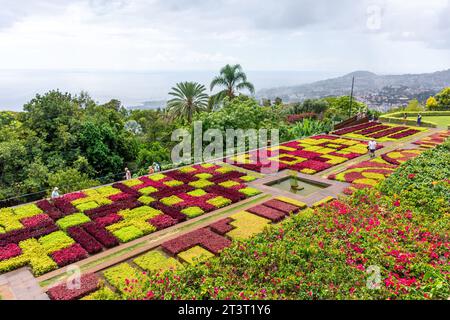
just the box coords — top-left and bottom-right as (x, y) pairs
(0, 268), (49, 300)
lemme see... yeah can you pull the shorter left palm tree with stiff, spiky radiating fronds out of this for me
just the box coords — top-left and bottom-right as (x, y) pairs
(167, 82), (208, 122)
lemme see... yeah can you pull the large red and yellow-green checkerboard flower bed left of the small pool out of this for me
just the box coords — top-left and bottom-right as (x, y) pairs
(0, 164), (260, 276)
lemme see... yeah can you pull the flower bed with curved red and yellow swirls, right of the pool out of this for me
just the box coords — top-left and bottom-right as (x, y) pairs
(328, 149), (422, 189)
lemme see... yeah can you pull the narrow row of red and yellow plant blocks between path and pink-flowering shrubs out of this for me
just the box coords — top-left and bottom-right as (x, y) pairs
(48, 197), (306, 300)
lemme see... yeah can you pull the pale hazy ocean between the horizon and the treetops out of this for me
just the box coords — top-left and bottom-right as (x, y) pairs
(0, 70), (339, 111)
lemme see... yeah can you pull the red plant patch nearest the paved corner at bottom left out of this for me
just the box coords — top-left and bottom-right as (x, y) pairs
(47, 274), (100, 300)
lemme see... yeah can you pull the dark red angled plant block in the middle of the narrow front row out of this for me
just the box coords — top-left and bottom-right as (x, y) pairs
(161, 228), (231, 255)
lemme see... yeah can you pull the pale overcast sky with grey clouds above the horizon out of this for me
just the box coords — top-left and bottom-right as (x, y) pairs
(0, 0), (450, 73)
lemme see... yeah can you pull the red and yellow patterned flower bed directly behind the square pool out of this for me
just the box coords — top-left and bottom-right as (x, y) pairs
(227, 135), (382, 174)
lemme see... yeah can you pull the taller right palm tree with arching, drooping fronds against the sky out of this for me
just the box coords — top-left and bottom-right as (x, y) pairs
(211, 64), (255, 100)
